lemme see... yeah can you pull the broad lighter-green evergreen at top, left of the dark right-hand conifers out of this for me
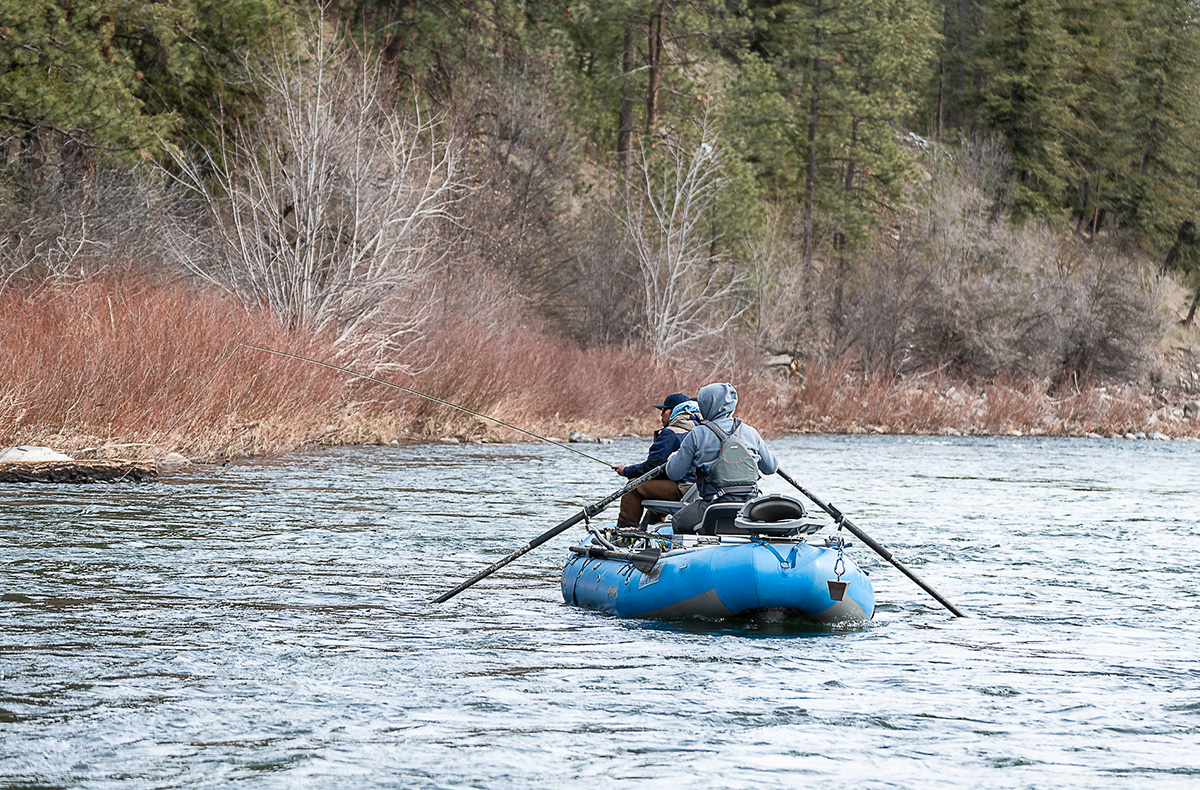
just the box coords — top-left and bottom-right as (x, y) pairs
(740, 0), (937, 263)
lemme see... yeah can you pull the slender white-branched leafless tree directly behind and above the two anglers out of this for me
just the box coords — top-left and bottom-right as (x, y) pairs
(618, 122), (746, 359)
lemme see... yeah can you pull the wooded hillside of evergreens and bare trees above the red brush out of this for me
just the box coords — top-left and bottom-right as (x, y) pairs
(0, 0), (1200, 449)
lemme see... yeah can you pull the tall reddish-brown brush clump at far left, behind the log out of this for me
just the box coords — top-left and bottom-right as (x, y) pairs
(0, 279), (348, 456)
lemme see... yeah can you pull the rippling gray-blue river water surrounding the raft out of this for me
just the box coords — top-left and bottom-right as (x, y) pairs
(0, 436), (1200, 790)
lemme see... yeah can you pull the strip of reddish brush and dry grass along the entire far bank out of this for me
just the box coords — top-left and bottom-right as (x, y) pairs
(0, 280), (1200, 461)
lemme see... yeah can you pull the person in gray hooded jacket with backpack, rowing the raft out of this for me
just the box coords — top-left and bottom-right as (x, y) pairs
(665, 383), (779, 533)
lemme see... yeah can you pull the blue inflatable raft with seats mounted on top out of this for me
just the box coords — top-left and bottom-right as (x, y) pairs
(562, 495), (875, 624)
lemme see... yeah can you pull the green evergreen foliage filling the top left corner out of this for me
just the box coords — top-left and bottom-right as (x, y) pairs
(0, 0), (282, 158)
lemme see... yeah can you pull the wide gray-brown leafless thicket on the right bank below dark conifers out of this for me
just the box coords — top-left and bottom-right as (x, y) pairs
(847, 139), (1164, 379)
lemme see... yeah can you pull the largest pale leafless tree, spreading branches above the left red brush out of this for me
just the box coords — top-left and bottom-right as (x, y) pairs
(172, 20), (462, 348)
